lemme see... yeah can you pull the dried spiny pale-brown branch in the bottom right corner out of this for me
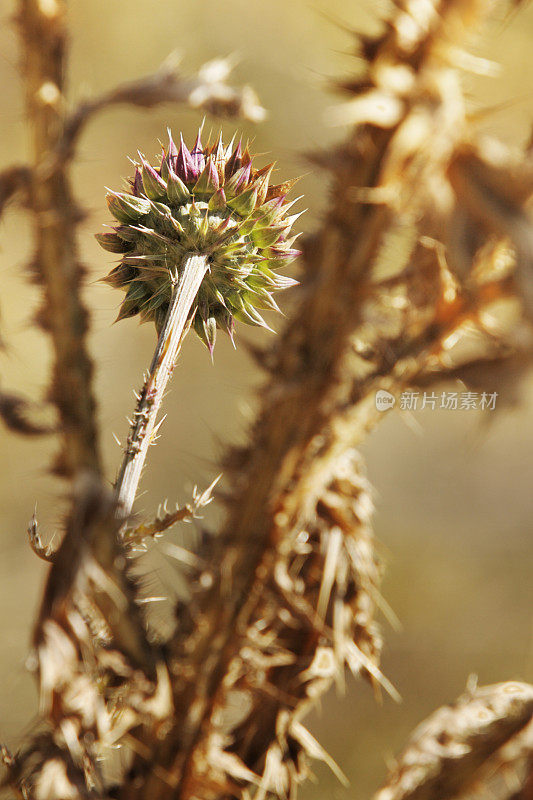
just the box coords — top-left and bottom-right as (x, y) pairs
(374, 683), (533, 800)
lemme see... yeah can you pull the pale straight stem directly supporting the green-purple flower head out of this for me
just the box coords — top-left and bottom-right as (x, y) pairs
(115, 253), (208, 517)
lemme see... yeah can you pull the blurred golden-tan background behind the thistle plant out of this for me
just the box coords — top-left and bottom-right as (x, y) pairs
(0, 0), (533, 800)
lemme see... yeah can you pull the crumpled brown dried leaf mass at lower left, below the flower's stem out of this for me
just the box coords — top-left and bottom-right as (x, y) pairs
(7, 474), (172, 800)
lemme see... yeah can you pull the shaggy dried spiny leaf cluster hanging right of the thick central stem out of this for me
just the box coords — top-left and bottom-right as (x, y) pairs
(178, 452), (386, 797)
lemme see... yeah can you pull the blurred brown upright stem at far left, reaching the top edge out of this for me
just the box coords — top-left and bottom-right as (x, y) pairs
(18, 0), (100, 475)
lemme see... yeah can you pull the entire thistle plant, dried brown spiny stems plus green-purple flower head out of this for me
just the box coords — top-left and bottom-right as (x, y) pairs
(0, 0), (533, 800)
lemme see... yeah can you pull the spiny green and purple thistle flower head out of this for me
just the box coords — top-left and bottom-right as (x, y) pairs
(96, 131), (300, 351)
